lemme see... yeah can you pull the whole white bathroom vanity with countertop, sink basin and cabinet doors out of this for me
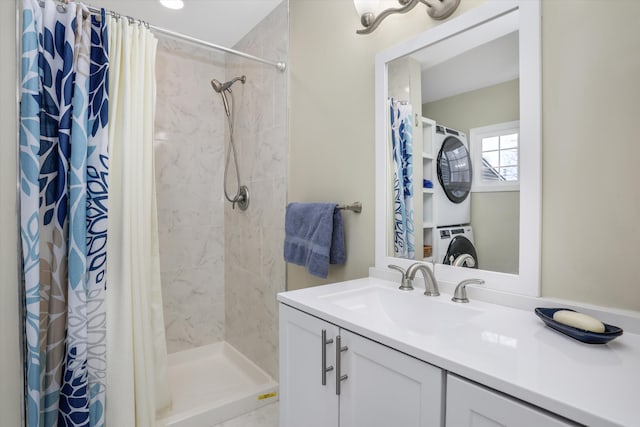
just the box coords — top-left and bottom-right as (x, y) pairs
(278, 277), (640, 427)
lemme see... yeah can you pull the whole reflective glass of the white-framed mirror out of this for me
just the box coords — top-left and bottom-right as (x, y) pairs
(387, 11), (521, 274)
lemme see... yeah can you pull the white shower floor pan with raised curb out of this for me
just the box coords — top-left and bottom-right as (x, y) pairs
(157, 342), (278, 427)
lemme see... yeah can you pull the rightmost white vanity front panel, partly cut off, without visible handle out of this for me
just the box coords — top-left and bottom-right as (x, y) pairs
(446, 374), (578, 427)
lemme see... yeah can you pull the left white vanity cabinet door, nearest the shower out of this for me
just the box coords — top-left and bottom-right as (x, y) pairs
(279, 304), (339, 427)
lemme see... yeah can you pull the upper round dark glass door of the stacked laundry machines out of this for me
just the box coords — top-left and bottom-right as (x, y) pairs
(438, 136), (473, 203)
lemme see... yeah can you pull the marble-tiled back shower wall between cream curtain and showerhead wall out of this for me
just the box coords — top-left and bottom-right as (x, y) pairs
(155, 39), (226, 353)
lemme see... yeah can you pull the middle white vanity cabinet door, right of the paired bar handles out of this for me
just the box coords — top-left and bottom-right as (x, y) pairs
(340, 329), (444, 427)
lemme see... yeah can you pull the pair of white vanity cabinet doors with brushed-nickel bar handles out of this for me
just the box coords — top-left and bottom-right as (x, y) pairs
(280, 304), (444, 427)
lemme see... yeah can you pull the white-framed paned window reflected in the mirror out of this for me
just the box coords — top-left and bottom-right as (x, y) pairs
(469, 122), (520, 191)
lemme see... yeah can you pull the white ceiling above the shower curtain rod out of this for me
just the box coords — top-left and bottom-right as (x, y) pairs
(87, 0), (283, 47)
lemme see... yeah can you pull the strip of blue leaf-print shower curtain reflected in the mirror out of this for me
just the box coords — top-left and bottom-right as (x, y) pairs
(389, 98), (415, 259)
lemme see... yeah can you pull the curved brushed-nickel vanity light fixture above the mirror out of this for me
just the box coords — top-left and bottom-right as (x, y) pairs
(353, 0), (460, 34)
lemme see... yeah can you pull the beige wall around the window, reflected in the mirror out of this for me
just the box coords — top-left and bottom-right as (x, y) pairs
(422, 80), (520, 273)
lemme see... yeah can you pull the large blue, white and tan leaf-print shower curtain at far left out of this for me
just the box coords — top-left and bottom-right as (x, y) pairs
(20, 0), (108, 426)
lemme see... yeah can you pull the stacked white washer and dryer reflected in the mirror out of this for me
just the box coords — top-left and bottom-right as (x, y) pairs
(433, 124), (478, 268)
